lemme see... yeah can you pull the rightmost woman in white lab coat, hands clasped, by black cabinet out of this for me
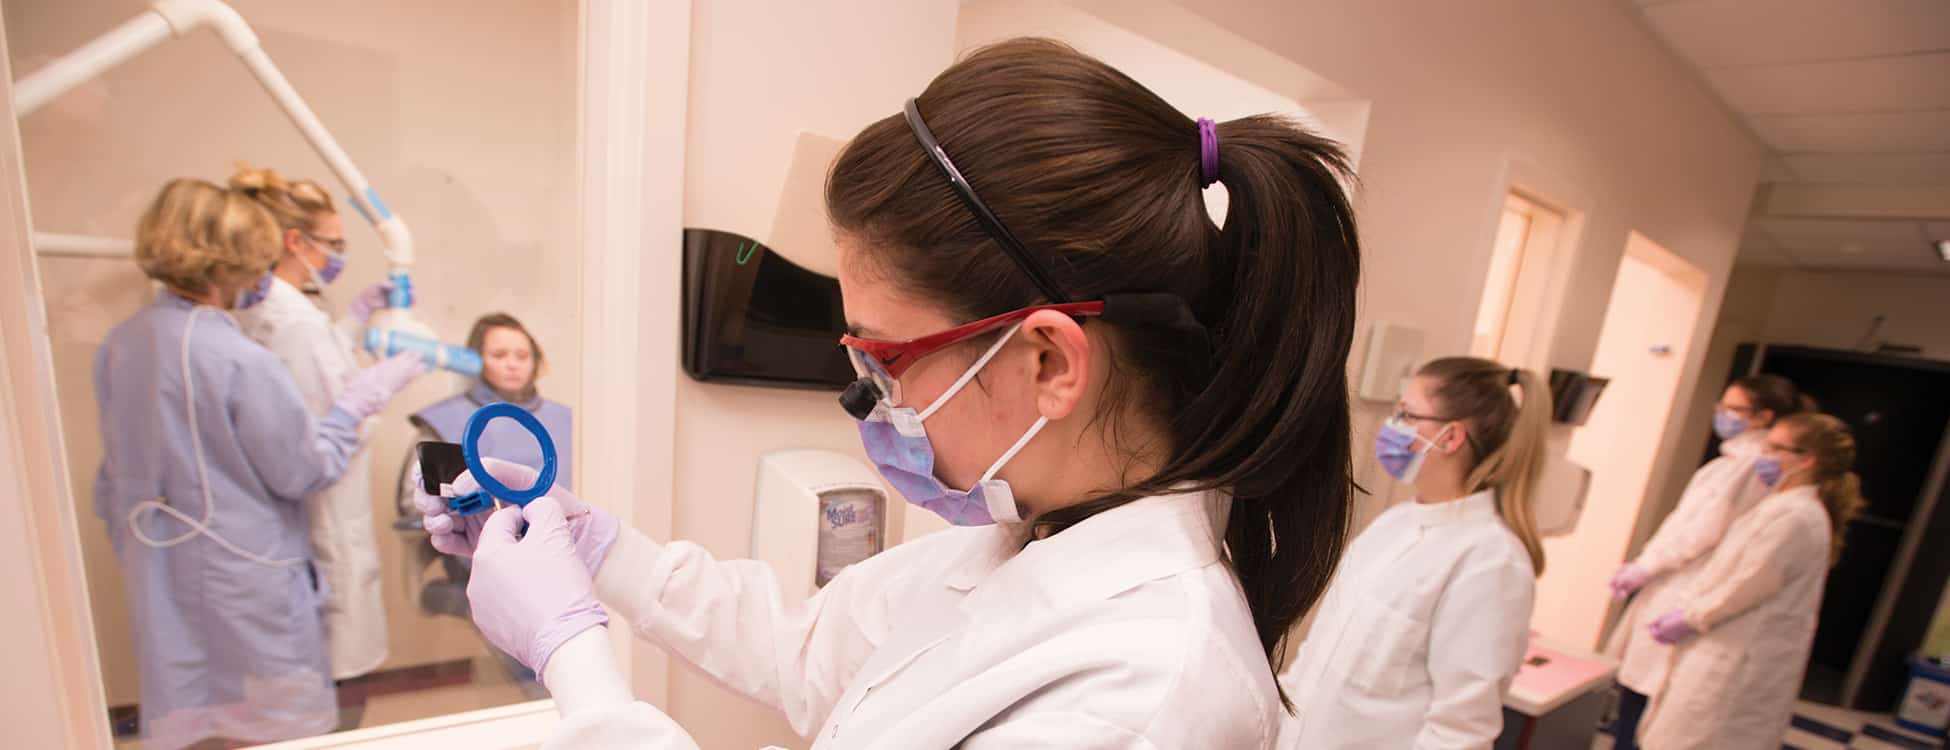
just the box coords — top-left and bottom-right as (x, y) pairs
(1640, 413), (1864, 750)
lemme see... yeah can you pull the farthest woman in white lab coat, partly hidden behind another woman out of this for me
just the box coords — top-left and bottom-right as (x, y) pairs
(1607, 374), (1814, 750)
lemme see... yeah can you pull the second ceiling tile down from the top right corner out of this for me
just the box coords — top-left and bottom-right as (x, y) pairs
(1706, 52), (1950, 115)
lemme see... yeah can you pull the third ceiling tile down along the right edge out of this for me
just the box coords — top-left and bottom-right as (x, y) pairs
(1747, 109), (1950, 154)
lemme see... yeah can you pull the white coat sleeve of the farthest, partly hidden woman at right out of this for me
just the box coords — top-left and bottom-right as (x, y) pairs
(1636, 456), (1767, 575)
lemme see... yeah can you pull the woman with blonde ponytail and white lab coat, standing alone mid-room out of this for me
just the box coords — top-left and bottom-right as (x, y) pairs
(1279, 356), (1550, 750)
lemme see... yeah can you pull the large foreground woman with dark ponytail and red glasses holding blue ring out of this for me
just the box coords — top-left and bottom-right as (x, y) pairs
(419, 39), (1359, 750)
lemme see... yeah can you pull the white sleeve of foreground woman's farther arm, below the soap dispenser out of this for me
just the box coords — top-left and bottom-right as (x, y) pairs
(597, 528), (926, 736)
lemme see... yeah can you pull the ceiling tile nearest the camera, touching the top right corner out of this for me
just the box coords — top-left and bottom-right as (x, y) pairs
(1642, 0), (1950, 68)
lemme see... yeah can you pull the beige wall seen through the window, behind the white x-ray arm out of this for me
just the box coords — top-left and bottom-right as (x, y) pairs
(4, 0), (581, 705)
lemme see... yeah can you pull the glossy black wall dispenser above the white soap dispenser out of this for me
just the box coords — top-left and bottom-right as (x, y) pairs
(683, 228), (854, 392)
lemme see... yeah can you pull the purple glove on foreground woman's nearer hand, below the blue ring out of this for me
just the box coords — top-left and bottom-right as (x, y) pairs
(468, 497), (608, 676)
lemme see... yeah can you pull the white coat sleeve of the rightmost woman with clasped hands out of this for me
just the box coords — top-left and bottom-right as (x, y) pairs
(1685, 514), (1827, 633)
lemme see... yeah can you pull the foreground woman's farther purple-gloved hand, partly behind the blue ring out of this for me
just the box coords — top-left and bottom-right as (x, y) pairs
(413, 458), (622, 577)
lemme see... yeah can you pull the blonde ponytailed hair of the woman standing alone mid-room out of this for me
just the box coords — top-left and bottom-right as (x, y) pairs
(1418, 356), (1550, 575)
